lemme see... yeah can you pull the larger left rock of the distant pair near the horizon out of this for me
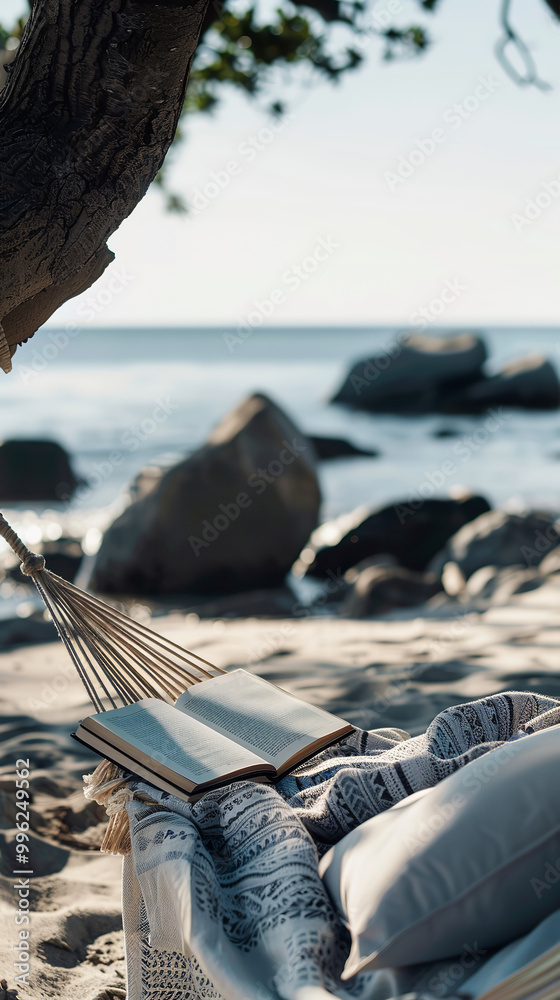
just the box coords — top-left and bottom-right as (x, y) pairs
(332, 333), (487, 413)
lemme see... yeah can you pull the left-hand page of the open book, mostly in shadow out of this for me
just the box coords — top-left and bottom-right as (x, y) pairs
(82, 698), (270, 784)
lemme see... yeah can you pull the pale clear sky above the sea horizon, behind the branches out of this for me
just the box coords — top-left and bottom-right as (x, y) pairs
(0, 0), (560, 331)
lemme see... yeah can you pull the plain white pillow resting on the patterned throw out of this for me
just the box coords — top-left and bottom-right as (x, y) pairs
(320, 726), (560, 979)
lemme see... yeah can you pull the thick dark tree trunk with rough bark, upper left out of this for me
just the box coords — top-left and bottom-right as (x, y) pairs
(0, 0), (208, 371)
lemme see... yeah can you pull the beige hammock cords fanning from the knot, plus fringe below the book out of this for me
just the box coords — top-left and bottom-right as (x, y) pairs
(0, 514), (225, 853)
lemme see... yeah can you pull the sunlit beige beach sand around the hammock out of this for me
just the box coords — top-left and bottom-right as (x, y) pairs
(0, 574), (560, 1000)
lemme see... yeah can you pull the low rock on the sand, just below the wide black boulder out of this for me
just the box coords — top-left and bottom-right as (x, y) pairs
(340, 566), (442, 618)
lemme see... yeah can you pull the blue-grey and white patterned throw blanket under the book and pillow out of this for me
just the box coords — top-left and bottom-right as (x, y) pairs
(118, 692), (560, 1000)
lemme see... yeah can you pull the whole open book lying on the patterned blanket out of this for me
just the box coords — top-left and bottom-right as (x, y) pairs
(72, 670), (353, 797)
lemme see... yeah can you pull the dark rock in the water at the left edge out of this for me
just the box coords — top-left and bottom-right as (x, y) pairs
(0, 439), (80, 503)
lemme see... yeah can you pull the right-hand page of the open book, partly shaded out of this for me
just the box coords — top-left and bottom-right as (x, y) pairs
(176, 670), (347, 768)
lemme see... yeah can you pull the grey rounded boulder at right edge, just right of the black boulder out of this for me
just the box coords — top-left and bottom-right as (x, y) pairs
(428, 510), (560, 580)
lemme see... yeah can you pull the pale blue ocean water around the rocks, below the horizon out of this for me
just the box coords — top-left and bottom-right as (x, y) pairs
(0, 327), (560, 580)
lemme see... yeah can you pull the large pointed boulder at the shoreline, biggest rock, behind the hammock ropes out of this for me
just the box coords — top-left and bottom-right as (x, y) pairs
(91, 395), (321, 594)
